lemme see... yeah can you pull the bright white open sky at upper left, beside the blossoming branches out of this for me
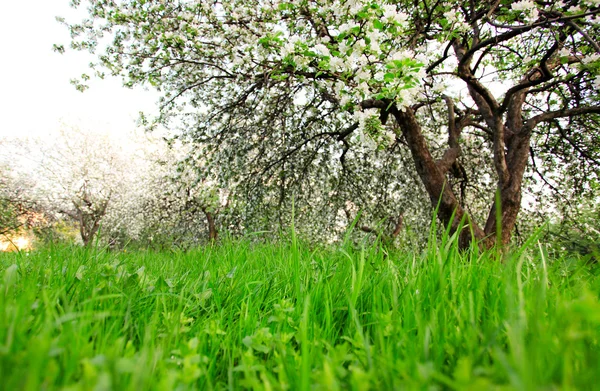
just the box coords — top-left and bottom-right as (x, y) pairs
(0, 0), (158, 138)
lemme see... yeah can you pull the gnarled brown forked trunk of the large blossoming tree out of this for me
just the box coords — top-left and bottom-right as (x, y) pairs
(362, 87), (545, 248)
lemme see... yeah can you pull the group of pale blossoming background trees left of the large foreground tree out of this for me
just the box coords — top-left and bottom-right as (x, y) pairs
(0, 125), (240, 248)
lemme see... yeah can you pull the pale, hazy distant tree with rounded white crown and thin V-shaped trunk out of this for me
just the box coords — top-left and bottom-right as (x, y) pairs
(31, 126), (128, 246)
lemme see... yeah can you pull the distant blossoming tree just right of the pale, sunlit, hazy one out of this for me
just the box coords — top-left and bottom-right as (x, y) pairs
(93, 134), (229, 248)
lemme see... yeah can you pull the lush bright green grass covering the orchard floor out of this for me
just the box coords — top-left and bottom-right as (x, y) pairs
(0, 234), (600, 391)
